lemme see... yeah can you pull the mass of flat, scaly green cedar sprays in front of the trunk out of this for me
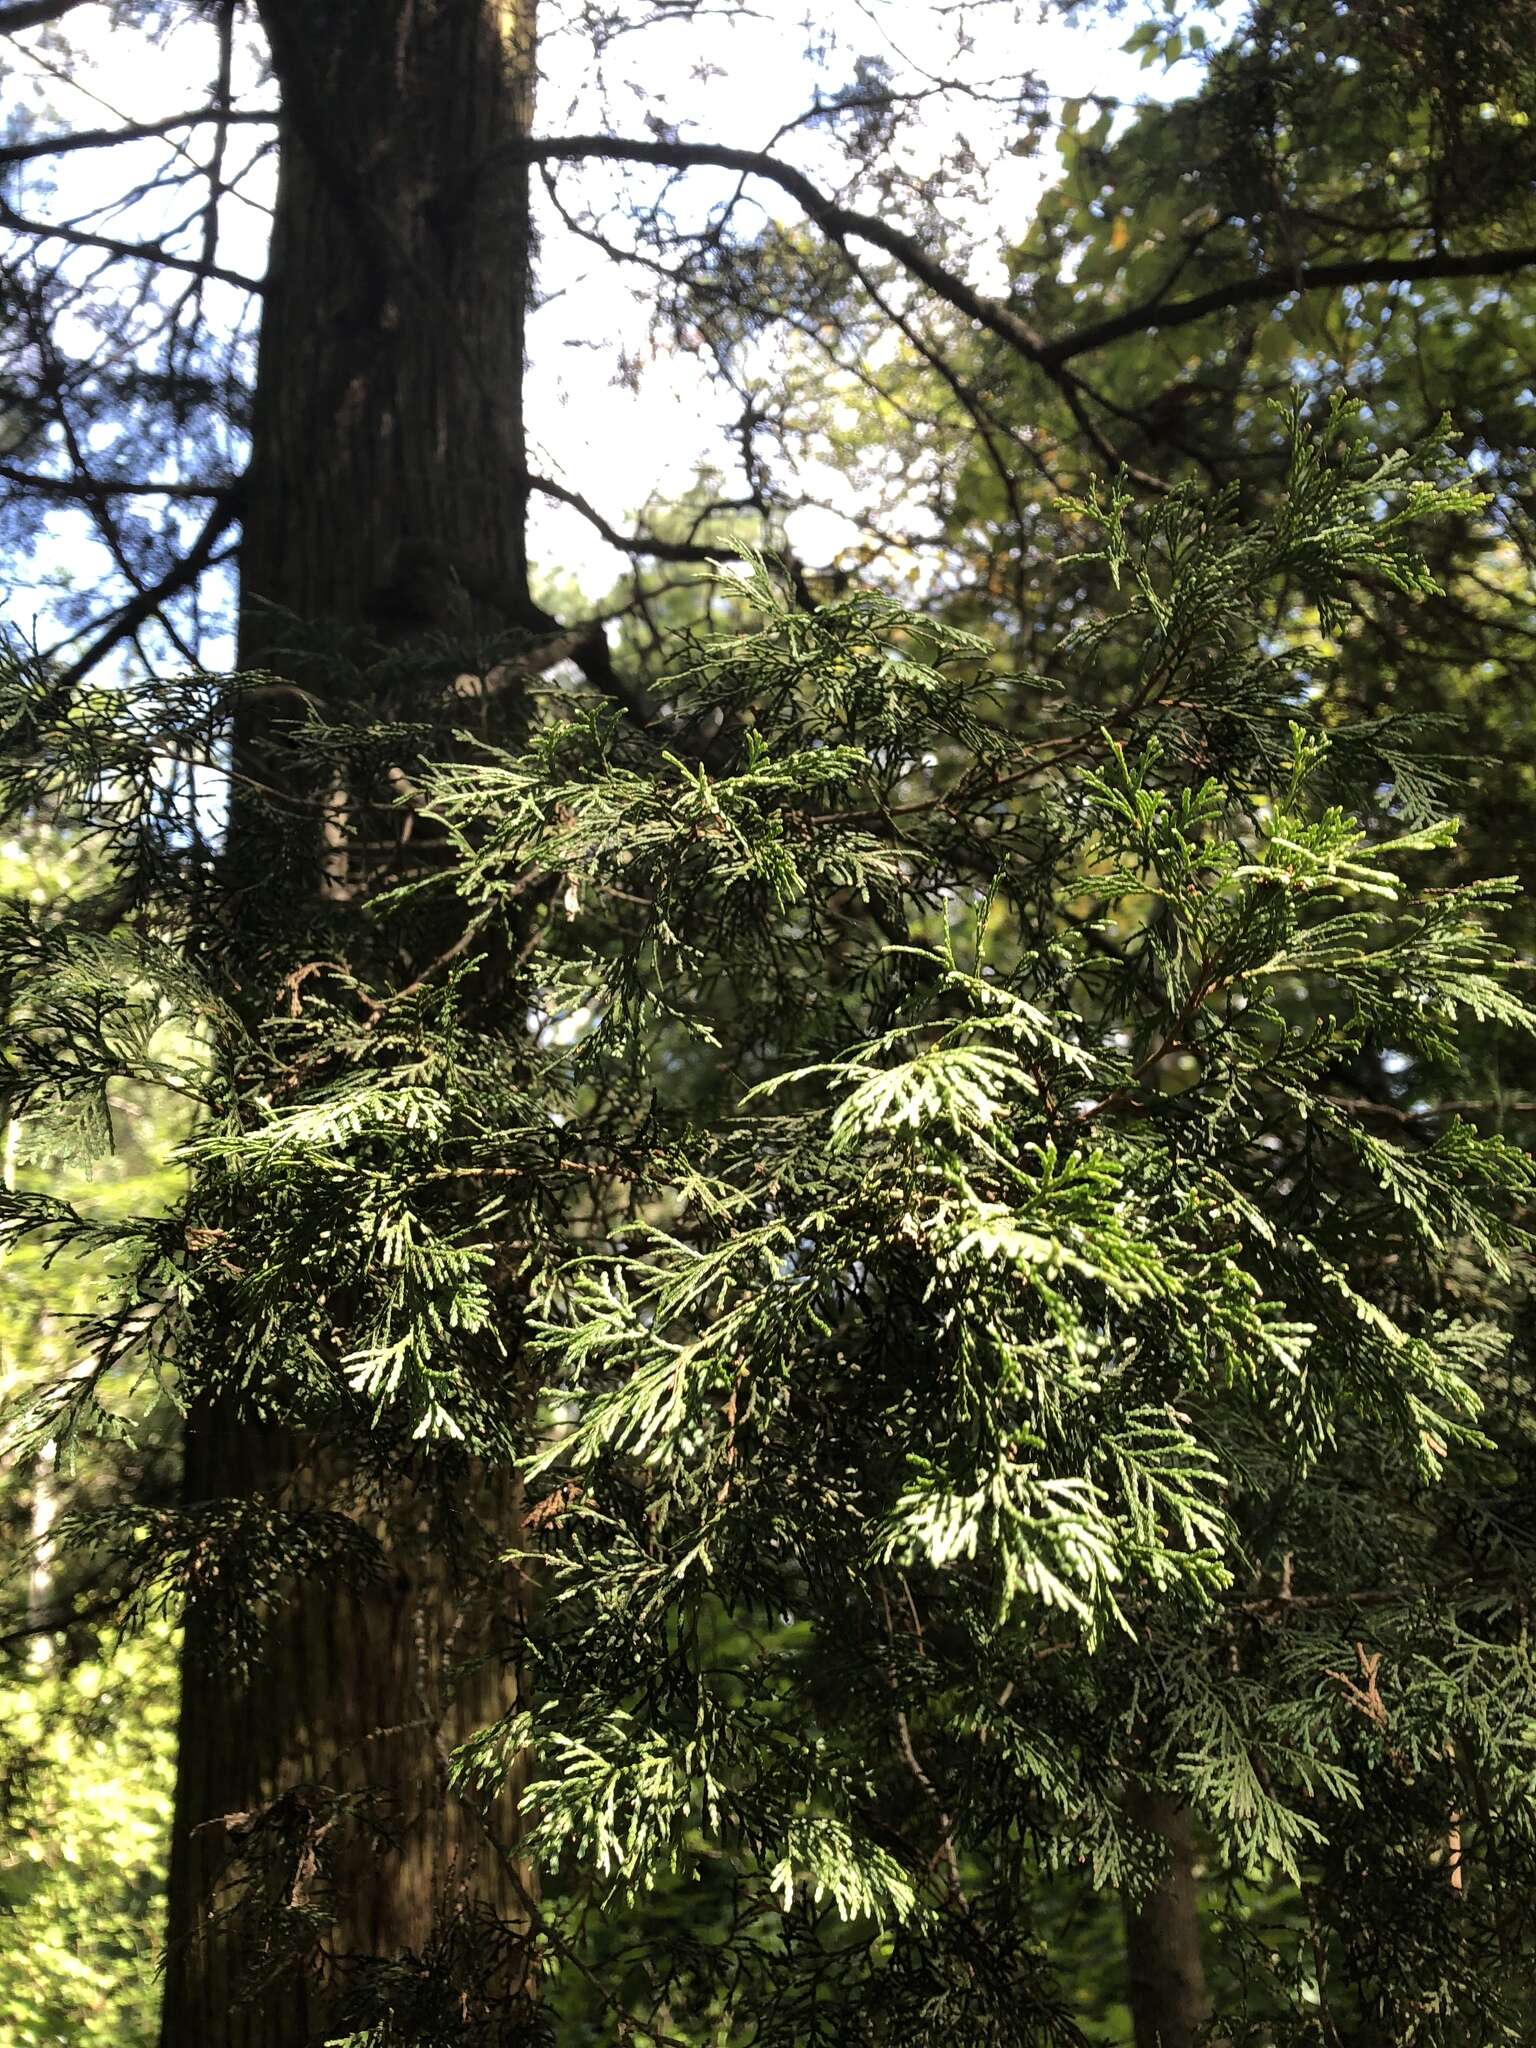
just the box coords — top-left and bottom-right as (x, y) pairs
(0, 408), (1536, 2048)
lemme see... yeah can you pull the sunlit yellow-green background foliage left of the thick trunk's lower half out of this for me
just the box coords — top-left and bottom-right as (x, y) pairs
(0, 817), (184, 2048)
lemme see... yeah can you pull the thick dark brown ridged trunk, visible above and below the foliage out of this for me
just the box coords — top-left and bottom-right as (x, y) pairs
(162, 0), (535, 2048)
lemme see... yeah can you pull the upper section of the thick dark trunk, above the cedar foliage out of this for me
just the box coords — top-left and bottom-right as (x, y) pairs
(240, 0), (535, 634)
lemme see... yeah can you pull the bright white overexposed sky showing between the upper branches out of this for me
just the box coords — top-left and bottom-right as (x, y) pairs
(4, 0), (1228, 638)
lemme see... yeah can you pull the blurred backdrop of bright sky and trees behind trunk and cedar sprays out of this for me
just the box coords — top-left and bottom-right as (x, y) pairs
(0, 0), (1536, 2048)
